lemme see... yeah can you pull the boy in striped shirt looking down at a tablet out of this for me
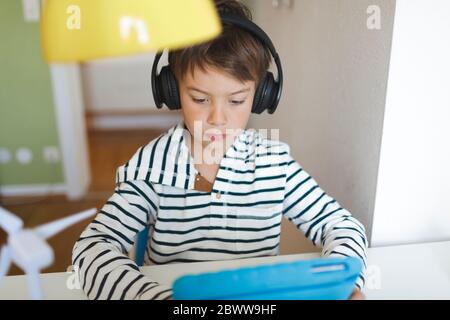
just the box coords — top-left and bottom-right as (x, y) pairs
(73, 0), (367, 299)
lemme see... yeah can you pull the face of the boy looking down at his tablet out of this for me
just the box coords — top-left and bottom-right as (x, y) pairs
(179, 68), (255, 151)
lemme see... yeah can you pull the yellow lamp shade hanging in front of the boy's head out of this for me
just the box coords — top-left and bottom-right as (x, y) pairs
(41, 0), (222, 63)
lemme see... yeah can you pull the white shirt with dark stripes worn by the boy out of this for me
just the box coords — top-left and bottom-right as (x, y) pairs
(72, 121), (367, 299)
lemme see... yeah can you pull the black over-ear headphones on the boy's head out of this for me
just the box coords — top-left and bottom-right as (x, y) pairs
(152, 14), (283, 114)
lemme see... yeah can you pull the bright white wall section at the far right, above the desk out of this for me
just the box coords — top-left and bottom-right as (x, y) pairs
(372, 0), (450, 245)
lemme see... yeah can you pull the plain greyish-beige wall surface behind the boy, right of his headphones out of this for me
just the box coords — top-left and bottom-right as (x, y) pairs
(250, 0), (395, 248)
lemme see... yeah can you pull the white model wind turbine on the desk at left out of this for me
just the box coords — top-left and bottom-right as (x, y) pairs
(0, 207), (97, 299)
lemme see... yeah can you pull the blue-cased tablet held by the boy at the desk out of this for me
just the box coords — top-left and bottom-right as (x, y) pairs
(172, 257), (362, 300)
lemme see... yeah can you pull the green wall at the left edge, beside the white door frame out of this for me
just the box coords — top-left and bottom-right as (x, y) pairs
(0, 0), (63, 191)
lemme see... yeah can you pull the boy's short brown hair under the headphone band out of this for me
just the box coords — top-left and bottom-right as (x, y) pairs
(169, 0), (271, 86)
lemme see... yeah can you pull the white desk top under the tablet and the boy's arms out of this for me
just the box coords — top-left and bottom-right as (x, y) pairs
(0, 241), (450, 299)
